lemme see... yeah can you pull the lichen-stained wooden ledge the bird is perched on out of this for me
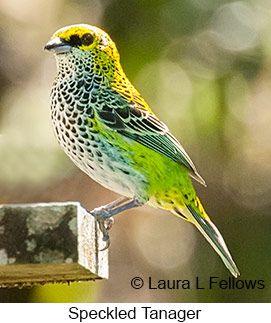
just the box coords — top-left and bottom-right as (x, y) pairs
(0, 202), (108, 287)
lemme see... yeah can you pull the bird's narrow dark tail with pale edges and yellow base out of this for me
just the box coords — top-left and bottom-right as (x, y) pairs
(173, 198), (240, 277)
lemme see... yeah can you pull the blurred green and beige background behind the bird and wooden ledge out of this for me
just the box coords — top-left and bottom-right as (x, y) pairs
(0, 0), (271, 302)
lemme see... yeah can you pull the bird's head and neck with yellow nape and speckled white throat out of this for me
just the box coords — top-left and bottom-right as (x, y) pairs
(45, 24), (138, 93)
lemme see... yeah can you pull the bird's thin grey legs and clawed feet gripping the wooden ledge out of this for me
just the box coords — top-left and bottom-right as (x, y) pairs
(89, 197), (144, 251)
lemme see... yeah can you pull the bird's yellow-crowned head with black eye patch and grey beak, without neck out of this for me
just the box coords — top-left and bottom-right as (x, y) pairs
(45, 24), (119, 64)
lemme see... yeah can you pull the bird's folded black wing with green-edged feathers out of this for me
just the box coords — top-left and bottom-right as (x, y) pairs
(98, 92), (206, 186)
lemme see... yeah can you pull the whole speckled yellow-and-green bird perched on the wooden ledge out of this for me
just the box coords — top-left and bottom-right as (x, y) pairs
(45, 24), (240, 277)
